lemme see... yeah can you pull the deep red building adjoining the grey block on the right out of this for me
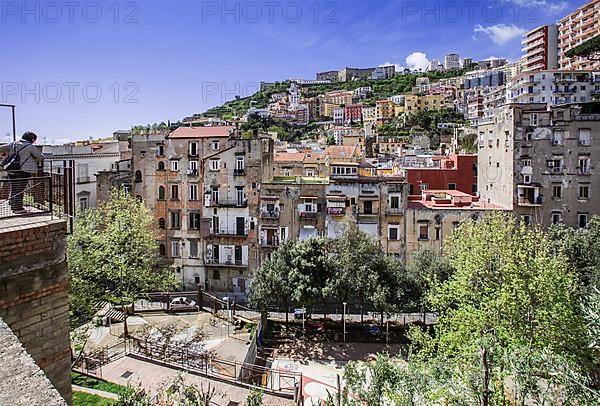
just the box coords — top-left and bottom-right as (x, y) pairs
(405, 155), (477, 195)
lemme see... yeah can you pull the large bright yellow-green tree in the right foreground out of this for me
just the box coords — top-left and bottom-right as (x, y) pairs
(428, 213), (586, 405)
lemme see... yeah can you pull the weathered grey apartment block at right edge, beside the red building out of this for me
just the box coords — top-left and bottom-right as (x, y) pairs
(478, 103), (600, 227)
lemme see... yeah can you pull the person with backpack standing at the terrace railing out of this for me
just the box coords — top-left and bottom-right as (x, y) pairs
(0, 131), (44, 214)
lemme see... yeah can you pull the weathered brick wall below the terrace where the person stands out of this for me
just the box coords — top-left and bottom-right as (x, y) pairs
(0, 217), (71, 404)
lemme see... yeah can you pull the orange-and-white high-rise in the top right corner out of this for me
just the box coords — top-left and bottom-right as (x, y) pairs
(558, 0), (600, 70)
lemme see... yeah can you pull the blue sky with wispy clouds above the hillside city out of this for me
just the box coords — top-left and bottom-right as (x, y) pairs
(0, 0), (585, 143)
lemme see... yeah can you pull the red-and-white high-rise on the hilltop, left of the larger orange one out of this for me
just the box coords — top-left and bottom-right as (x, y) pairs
(521, 24), (558, 72)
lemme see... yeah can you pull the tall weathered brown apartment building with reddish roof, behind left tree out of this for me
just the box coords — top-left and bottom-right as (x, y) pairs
(132, 126), (272, 292)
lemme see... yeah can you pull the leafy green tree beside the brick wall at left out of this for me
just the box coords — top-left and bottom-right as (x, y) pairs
(67, 189), (175, 335)
